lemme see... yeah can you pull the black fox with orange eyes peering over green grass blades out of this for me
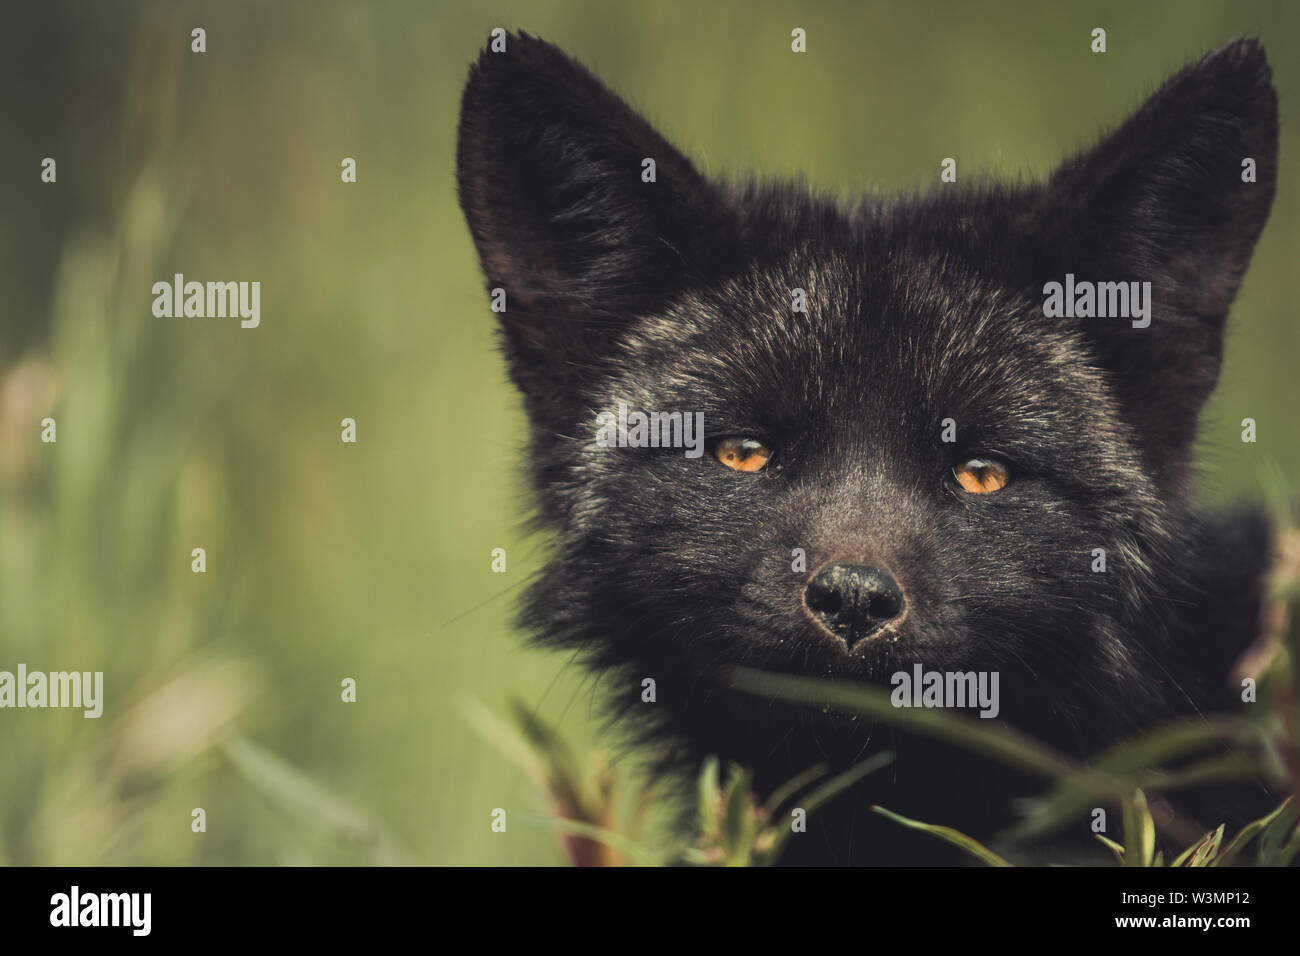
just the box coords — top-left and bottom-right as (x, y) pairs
(458, 34), (1278, 864)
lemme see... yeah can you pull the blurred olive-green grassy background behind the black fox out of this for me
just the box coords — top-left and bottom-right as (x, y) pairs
(0, 0), (1300, 864)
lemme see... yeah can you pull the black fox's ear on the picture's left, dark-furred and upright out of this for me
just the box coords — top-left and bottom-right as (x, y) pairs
(456, 34), (741, 427)
